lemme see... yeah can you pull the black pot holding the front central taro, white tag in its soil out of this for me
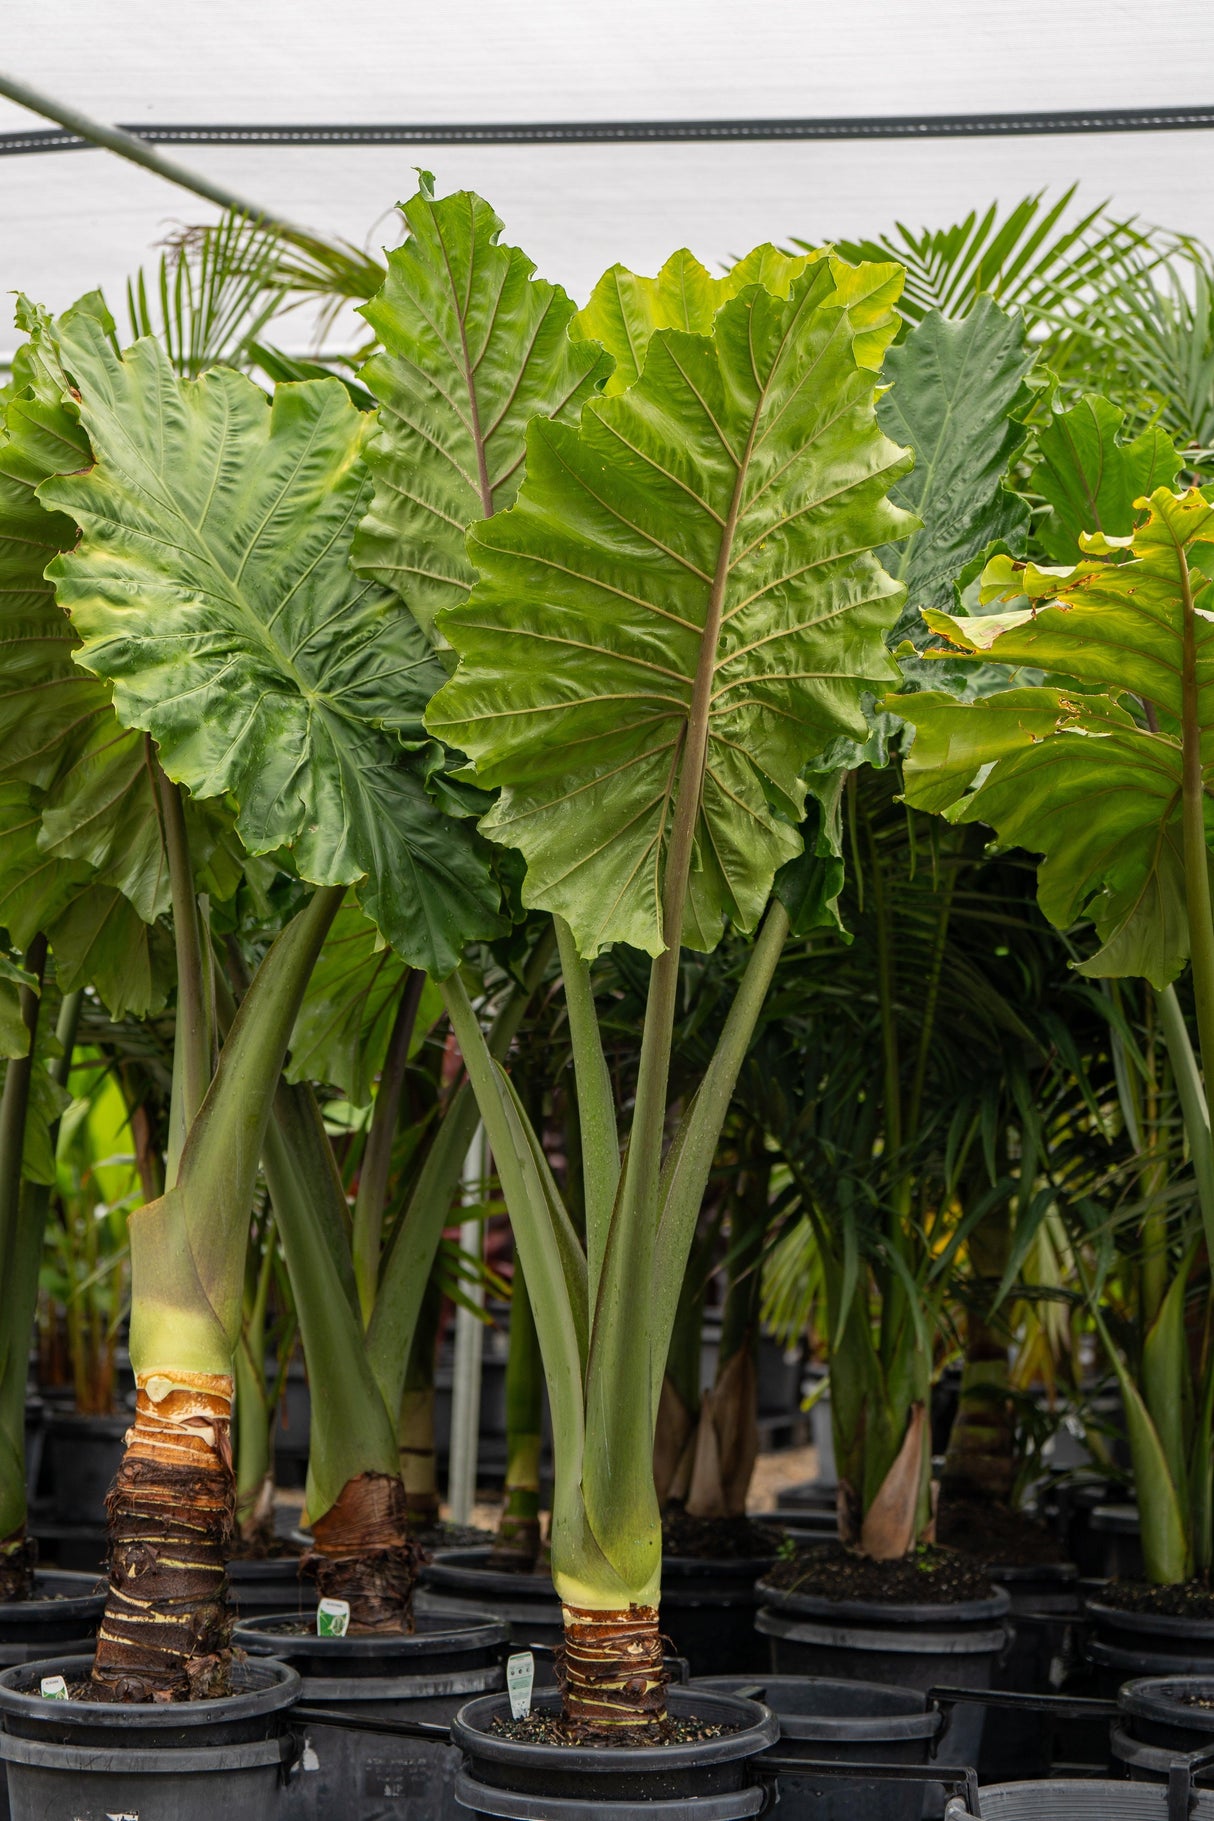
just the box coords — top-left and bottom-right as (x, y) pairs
(451, 1688), (779, 1821)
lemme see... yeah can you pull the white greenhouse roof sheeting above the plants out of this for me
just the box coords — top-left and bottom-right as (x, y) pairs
(0, 0), (1214, 357)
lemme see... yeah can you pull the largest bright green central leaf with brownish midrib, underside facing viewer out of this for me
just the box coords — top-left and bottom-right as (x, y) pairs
(428, 260), (914, 956)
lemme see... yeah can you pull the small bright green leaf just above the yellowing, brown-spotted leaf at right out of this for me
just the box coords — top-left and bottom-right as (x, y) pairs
(1033, 393), (1181, 560)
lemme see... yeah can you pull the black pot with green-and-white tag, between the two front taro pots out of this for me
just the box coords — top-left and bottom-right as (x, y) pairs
(235, 1610), (508, 1821)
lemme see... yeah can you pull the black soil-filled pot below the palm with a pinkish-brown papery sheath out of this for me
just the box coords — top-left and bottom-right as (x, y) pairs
(755, 1581), (1012, 1765)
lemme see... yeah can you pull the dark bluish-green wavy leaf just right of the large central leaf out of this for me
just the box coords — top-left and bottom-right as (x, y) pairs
(877, 297), (1034, 632)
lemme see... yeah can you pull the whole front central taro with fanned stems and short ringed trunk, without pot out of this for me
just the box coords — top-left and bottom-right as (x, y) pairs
(428, 249), (914, 1726)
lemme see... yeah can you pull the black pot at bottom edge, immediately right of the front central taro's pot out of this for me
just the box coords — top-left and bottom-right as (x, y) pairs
(690, 1675), (945, 1821)
